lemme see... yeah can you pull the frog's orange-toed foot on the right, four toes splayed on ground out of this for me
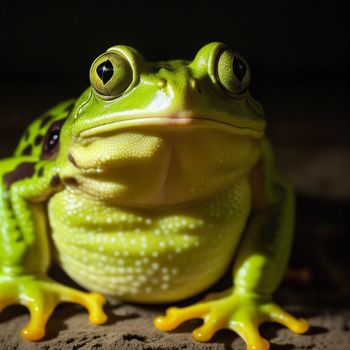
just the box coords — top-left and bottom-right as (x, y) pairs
(154, 292), (308, 350)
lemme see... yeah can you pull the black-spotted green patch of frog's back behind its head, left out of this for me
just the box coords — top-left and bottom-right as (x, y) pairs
(14, 99), (76, 158)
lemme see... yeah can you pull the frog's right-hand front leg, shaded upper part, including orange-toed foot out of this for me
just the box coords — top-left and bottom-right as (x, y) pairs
(155, 144), (308, 350)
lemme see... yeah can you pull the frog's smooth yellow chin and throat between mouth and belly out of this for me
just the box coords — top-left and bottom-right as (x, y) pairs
(62, 121), (260, 207)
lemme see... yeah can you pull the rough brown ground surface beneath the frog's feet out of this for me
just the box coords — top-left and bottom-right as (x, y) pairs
(0, 303), (350, 350)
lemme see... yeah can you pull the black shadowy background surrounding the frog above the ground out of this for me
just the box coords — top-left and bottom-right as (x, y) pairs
(0, 0), (350, 296)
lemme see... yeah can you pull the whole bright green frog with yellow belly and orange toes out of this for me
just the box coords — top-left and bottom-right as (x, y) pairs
(0, 42), (308, 349)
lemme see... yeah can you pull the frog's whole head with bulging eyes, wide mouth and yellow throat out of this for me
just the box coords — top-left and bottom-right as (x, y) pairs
(60, 42), (265, 206)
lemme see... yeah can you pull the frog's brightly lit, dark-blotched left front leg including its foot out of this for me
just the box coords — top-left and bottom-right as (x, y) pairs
(0, 159), (106, 340)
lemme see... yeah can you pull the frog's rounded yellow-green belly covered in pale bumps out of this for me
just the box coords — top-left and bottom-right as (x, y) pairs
(49, 180), (250, 303)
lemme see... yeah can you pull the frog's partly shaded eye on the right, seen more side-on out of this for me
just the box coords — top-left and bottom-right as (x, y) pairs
(216, 49), (250, 95)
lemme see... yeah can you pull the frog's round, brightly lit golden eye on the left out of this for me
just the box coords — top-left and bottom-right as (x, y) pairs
(90, 52), (133, 99)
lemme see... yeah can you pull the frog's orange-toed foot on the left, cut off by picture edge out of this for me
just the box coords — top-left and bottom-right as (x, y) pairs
(0, 276), (107, 341)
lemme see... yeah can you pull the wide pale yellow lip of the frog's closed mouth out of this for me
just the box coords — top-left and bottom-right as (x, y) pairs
(79, 115), (264, 138)
